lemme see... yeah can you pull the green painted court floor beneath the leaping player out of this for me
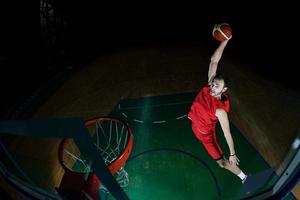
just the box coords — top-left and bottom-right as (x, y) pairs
(102, 92), (274, 200)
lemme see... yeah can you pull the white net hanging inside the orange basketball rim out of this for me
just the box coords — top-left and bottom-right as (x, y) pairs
(63, 118), (130, 187)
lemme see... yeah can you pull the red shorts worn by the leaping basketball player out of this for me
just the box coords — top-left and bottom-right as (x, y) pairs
(192, 124), (223, 160)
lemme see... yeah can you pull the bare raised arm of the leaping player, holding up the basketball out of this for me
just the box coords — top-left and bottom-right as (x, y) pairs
(208, 40), (228, 85)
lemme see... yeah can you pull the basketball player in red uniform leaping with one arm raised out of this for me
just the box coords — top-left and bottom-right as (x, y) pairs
(188, 32), (247, 183)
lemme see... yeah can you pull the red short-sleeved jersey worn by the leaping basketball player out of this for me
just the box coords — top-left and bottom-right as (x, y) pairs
(188, 85), (230, 134)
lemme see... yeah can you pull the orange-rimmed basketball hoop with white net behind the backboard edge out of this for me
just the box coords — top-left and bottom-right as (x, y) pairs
(58, 117), (133, 196)
